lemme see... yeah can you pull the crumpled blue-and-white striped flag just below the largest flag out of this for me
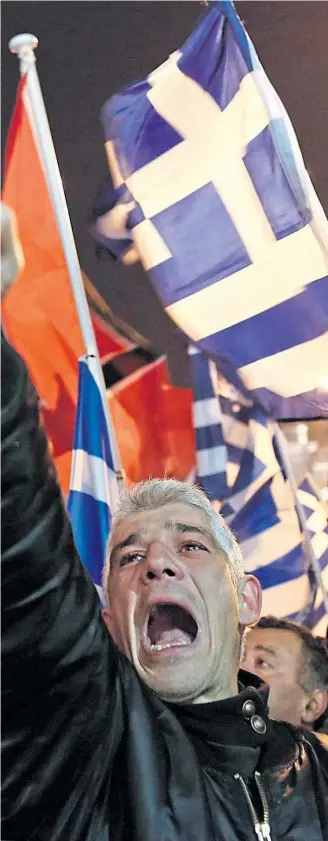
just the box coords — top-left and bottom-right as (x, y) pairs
(189, 348), (314, 622)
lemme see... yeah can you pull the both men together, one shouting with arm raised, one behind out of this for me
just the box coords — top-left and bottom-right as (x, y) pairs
(1, 200), (328, 841)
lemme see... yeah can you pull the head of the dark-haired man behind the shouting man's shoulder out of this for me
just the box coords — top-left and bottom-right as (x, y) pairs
(242, 616), (328, 732)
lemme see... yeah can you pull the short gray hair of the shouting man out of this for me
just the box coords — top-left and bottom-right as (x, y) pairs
(103, 479), (245, 599)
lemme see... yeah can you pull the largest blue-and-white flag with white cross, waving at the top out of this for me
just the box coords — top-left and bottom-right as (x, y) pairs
(93, 2), (328, 418)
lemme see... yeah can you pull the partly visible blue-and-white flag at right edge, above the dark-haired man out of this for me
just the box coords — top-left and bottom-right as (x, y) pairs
(298, 476), (328, 636)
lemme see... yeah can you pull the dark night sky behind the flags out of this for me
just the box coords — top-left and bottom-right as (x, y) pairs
(2, 0), (328, 384)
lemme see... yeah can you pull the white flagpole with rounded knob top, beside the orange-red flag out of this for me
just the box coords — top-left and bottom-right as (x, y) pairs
(9, 33), (123, 487)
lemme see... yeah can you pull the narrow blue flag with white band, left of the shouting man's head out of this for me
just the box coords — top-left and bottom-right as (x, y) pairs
(68, 357), (119, 598)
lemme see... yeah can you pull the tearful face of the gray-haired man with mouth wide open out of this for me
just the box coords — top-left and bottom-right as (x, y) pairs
(104, 503), (240, 703)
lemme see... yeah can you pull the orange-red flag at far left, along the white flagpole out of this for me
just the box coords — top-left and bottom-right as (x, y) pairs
(3, 79), (131, 494)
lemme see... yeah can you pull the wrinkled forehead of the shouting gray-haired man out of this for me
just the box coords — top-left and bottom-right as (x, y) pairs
(111, 503), (216, 546)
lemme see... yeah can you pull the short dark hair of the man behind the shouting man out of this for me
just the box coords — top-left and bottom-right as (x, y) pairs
(256, 616), (328, 727)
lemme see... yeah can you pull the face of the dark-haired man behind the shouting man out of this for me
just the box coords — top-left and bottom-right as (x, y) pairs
(242, 628), (308, 725)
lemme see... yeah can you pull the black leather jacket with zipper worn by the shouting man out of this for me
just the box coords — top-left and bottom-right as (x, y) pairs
(2, 334), (328, 841)
